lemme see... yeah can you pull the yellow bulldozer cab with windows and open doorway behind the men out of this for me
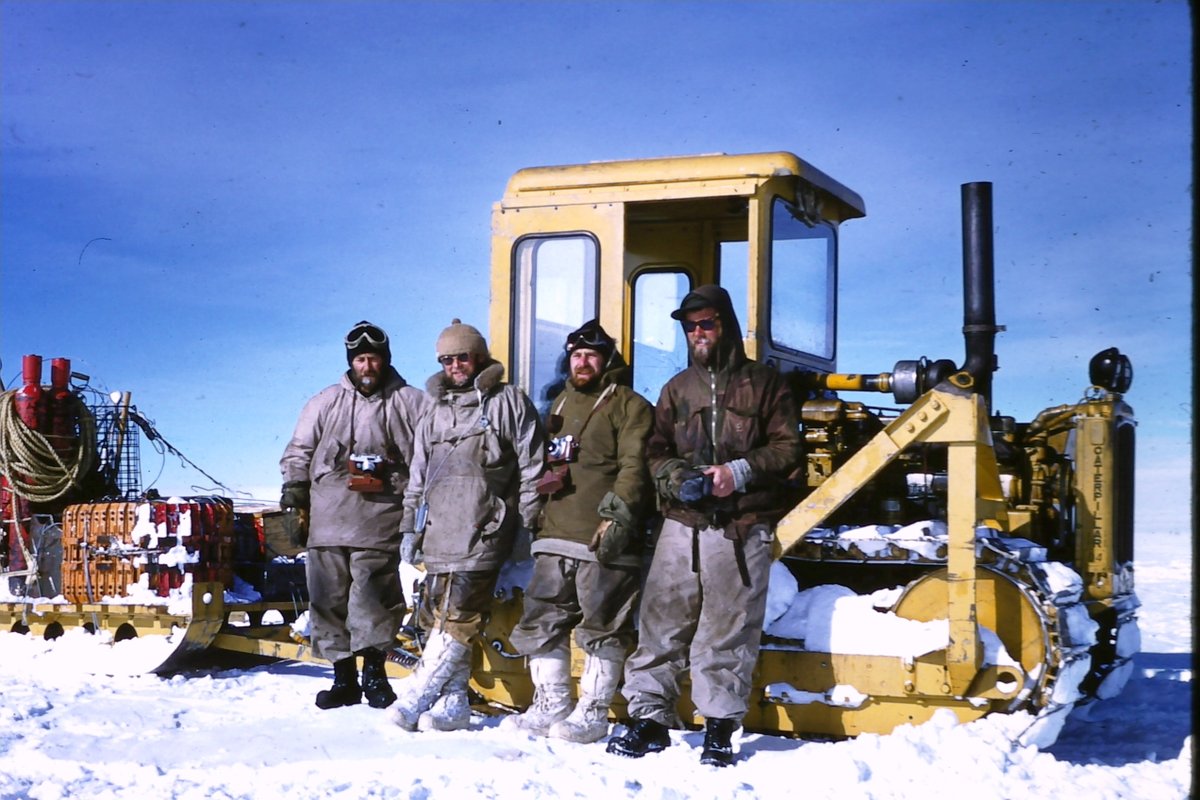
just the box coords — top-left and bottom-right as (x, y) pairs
(490, 152), (864, 413)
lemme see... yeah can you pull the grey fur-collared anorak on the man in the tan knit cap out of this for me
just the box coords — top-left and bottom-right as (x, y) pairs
(401, 360), (546, 573)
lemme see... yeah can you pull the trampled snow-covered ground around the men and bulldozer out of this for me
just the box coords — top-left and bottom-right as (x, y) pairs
(0, 534), (1192, 800)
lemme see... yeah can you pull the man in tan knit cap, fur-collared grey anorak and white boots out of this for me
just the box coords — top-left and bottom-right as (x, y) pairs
(390, 319), (546, 730)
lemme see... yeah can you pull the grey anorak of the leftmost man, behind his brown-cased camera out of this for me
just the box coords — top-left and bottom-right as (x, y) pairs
(280, 367), (427, 552)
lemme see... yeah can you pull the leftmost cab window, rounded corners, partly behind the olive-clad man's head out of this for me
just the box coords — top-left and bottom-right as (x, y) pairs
(511, 234), (599, 415)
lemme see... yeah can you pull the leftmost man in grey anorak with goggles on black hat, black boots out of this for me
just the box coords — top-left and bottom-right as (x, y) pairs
(280, 320), (426, 709)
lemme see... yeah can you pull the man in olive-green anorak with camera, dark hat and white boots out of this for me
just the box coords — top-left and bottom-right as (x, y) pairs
(502, 320), (653, 742)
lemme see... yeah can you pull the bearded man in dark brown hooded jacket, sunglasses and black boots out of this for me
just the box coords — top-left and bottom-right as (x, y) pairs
(608, 285), (802, 766)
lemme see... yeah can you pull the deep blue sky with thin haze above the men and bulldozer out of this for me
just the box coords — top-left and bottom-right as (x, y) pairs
(0, 0), (1194, 531)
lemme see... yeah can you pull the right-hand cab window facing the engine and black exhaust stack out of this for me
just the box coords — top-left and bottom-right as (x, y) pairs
(770, 197), (838, 360)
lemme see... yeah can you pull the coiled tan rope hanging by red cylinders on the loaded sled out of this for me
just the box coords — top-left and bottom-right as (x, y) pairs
(0, 390), (96, 503)
